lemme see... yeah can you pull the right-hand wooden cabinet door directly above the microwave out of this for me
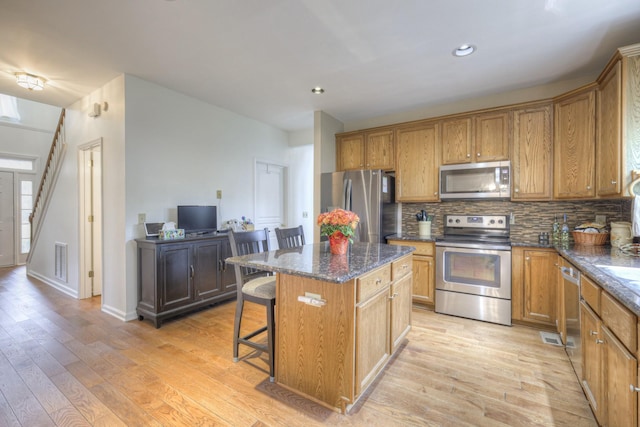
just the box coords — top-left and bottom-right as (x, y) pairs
(472, 111), (509, 162)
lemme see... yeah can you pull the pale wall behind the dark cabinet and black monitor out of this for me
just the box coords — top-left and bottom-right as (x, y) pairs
(125, 76), (304, 318)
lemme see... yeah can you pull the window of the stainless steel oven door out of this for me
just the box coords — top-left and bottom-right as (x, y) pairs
(444, 251), (500, 288)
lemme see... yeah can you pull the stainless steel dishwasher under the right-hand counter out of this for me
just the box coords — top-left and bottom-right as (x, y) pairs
(560, 260), (582, 378)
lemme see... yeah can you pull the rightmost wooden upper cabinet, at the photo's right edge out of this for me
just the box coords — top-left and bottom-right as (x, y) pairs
(596, 44), (640, 197)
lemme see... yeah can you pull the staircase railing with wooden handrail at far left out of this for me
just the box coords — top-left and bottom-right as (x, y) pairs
(27, 108), (67, 264)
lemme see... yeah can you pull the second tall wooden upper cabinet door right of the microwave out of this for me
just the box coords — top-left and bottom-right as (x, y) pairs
(553, 85), (596, 199)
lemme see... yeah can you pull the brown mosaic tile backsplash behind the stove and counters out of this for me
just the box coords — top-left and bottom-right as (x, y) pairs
(402, 199), (632, 242)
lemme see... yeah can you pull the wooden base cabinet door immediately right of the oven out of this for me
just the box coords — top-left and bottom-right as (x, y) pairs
(523, 250), (558, 326)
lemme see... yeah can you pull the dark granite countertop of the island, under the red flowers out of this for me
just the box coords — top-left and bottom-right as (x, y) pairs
(226, 242), (415, 283)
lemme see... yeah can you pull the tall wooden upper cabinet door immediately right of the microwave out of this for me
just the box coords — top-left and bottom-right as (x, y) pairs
(511, 105), (553, 200)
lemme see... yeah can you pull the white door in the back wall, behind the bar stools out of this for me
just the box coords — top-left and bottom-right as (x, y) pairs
(255, 160), (287, 249)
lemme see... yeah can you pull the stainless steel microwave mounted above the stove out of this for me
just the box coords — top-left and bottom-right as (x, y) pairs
(440, 161), (511, 199)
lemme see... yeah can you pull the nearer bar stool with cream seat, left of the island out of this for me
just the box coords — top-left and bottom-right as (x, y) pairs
(229, 228), (276, 382)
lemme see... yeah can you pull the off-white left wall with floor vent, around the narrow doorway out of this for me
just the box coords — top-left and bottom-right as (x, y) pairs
(28, 76), (125, 312)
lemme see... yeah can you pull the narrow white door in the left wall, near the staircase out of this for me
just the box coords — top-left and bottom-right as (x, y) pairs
(78, 140), (102, 298)
